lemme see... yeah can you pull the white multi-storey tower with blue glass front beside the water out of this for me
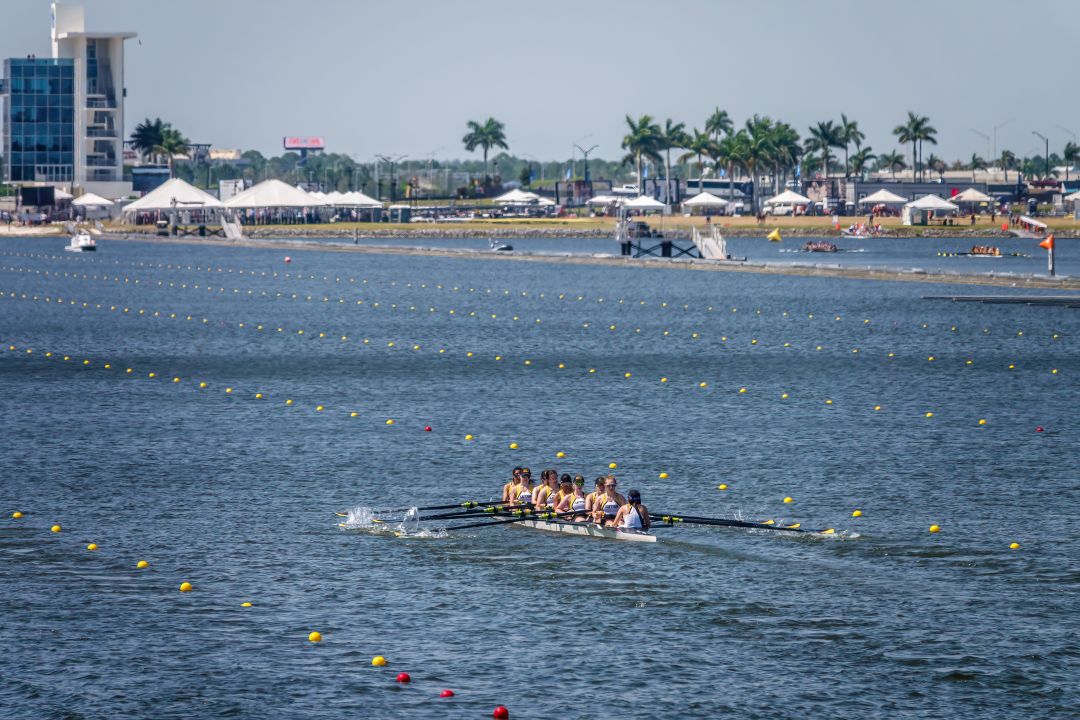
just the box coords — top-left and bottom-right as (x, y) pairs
(0, 2), (135, 198)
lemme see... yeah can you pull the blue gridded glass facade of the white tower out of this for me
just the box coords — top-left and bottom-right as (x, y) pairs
(3, 58), (76, 182)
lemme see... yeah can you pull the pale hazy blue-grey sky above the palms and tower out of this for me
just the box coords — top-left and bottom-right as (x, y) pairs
(0, 0), (1080, 161)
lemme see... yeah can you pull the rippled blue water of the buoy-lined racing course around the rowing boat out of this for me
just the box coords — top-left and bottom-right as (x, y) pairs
(0, 241), (1080, 718)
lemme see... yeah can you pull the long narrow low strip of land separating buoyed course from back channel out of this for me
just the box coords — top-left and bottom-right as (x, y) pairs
(71, 235), (1080, 291)
